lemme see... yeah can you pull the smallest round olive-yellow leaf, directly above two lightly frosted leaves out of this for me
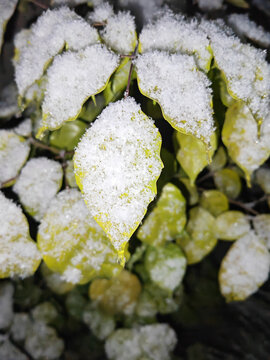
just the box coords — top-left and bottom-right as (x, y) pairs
(200, 190), (229, 216)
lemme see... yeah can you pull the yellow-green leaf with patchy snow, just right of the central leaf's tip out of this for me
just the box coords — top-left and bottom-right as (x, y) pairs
(137, 183), (186, 246)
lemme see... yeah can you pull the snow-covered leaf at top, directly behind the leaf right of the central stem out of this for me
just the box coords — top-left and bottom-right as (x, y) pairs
(139, 11), (212, 72)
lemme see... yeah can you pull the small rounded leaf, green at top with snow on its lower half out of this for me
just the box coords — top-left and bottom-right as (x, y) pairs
(145, 243), (187, 293)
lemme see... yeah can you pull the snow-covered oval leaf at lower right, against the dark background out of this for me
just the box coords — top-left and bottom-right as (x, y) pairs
(219, 231), (270, 301)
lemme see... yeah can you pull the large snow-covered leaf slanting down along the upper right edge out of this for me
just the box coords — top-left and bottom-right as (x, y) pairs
(201, 21), (270, 125)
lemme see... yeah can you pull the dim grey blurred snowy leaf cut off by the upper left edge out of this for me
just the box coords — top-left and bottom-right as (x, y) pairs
(0, 83), (19, 118)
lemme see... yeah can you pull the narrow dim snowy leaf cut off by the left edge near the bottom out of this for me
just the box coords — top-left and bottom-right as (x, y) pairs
(0, 282), (14, 330)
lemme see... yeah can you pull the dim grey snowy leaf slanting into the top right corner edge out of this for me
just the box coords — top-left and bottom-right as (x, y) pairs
(228, 14), (270, 47)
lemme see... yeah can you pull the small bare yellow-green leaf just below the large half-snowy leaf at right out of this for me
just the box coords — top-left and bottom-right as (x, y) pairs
(214, 168), (242, 199)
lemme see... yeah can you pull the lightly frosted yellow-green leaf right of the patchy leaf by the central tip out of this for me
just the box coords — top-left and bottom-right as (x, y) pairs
(177, 206), (217, 264)
